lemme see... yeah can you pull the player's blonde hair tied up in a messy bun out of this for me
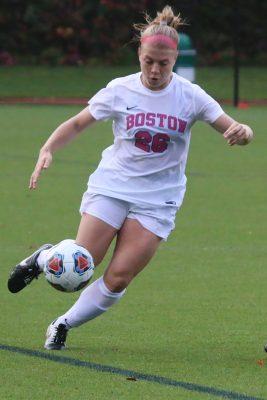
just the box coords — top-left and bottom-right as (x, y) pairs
(134, 6), (186, 44)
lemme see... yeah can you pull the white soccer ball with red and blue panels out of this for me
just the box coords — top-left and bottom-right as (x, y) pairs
(44, 239), (94, 292)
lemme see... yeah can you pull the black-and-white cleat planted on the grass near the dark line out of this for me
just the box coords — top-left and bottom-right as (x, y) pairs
(44, 320), (68, 350)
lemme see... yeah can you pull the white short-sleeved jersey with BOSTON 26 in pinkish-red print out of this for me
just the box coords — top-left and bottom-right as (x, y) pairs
(88, 72), (223, 208)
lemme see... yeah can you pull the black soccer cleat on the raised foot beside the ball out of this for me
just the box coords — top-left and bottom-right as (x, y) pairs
(7, 244), (53, 293)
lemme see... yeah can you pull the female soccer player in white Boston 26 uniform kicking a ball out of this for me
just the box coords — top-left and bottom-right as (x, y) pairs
(8, 6), (253, 350)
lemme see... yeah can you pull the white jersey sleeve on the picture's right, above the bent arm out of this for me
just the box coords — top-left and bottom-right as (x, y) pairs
(194, 85), (224, 124)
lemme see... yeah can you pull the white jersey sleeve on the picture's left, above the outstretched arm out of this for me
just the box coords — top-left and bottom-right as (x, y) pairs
(88, 85), (114, 120)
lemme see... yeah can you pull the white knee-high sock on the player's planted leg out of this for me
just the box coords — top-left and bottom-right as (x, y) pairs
(57, 276), (126, 328)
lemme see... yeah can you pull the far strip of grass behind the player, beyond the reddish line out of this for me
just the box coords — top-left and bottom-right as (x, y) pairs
(0, 65), (267, 100)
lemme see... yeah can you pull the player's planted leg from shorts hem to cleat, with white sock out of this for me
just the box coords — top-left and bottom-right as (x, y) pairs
(45, 219), (161, 350)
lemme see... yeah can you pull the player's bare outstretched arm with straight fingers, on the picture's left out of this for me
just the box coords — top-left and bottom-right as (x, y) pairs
(29, 107), (95, 189)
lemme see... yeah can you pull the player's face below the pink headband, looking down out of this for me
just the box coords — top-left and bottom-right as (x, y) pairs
(138, 43), (178, 90)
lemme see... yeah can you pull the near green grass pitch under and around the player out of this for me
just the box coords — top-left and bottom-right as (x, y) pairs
(0, 106), (267, 400)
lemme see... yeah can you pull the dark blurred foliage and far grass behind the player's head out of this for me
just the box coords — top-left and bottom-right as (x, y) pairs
(0, 0), (267, 103)
